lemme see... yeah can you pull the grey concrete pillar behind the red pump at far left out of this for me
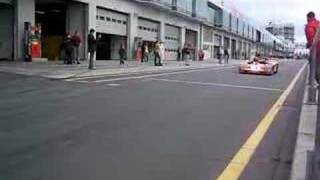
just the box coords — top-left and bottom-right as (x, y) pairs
(14, 0), (35, 60)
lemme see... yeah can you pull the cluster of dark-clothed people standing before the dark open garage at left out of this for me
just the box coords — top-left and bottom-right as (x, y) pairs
(61, 31), (82, 64)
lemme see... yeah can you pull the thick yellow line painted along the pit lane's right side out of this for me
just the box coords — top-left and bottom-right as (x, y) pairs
(217, 63), (307, 180)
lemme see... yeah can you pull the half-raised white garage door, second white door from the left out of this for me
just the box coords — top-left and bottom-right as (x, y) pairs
(138, 18), (160, 42)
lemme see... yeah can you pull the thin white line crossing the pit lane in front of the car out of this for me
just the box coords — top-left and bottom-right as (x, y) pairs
(148, 78), (283, 92)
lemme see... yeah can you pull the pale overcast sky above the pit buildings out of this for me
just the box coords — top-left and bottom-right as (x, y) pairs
(212, 0), (320, 42)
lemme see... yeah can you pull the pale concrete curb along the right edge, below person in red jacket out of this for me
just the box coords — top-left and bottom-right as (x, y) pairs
(290, 68), (317, 180)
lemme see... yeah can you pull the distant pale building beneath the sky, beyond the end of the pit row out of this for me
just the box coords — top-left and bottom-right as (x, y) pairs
(266, 22), (295, 43)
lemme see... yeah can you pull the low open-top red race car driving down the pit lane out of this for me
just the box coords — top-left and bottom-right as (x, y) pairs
(239, 57), (279, 75)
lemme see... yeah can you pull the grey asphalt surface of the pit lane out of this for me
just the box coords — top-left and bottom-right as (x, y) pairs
(0, 61), (304, 180)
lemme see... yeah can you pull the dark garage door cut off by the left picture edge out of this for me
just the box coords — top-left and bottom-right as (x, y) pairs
(0, 4), (13, 59)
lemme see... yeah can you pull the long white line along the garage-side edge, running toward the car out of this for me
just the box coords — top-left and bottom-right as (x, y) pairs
(73, 66), (235, 83)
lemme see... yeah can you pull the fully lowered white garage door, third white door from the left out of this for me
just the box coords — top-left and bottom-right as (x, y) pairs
(165, 25), (180, 60)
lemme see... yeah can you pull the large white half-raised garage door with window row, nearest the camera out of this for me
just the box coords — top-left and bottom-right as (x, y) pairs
(96, 8), (128, 36)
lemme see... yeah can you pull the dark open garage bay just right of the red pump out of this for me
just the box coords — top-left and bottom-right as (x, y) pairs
(35, 0), (87, 60)
